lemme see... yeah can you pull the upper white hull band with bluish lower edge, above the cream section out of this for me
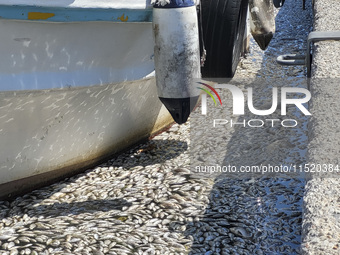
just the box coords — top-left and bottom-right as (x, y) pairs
(0, 19), (154, 90)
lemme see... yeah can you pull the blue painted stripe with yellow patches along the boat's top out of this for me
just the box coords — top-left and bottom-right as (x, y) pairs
(0, 5), (152, 22)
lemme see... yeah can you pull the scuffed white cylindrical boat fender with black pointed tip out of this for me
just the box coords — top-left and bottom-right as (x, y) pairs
(153, 0), (201, 124)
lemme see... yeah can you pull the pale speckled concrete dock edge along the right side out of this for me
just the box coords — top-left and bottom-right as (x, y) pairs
(302, 0), (340, 254)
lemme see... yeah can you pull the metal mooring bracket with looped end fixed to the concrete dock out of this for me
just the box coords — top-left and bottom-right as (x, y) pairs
(276, 30), (340, 78)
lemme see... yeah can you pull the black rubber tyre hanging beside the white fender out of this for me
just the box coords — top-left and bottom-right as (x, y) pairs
(199, 0), (248, 78)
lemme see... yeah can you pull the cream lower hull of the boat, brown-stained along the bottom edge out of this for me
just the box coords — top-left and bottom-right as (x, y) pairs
(0, 78), (172, 197)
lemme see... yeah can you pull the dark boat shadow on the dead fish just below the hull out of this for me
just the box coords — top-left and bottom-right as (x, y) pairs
(0, 139), (188, 220)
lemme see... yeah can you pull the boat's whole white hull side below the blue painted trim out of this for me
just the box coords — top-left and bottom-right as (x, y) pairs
(0, 5), (172, 198)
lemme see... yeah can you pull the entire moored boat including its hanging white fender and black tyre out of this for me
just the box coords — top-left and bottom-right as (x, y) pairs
(0, 0), (274, 199)
